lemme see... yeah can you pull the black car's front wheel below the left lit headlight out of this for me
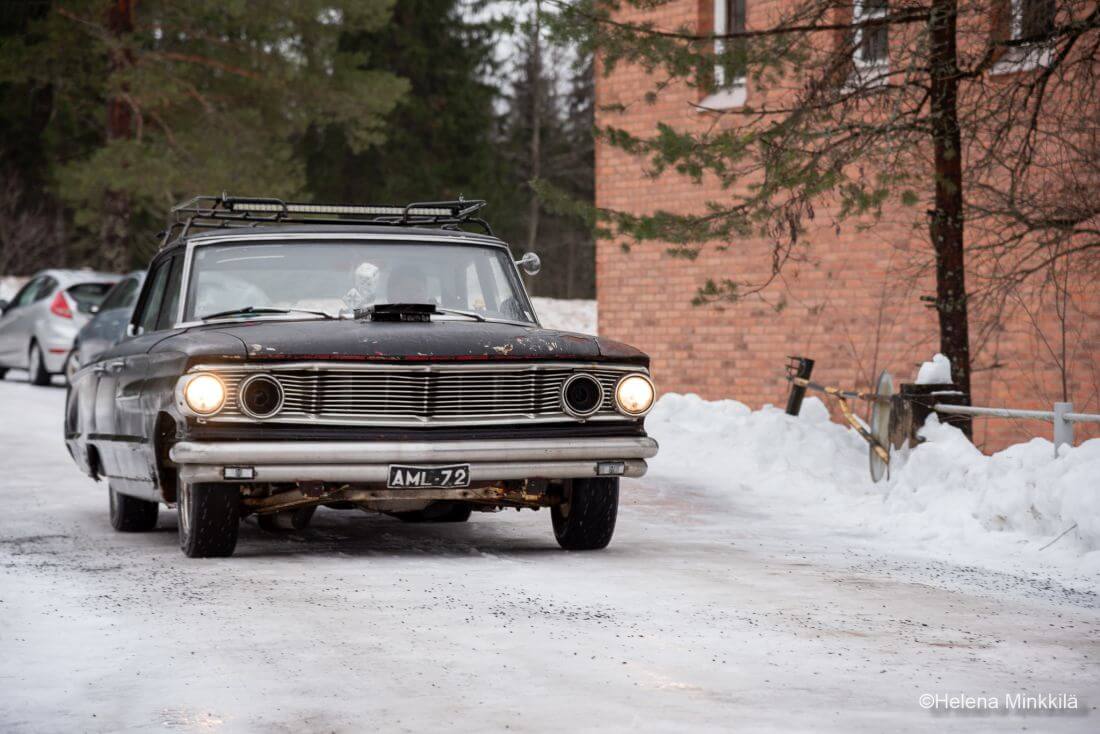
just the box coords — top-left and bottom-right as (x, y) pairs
(178, 482), (241, 558)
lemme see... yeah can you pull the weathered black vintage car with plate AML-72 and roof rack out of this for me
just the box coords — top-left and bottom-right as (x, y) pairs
(65, 196), (657, 557)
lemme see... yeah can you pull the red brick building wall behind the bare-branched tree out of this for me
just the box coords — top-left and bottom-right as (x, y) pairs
(596, 0), (1100, 449)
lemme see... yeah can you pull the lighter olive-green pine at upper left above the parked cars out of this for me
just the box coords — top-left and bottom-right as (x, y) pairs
(0, 0), (407, 270)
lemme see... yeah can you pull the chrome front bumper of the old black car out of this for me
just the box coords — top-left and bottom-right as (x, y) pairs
(169, 437), (657, 485)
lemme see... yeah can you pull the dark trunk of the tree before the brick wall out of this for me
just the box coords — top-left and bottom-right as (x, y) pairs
(928, 0), (972, 437)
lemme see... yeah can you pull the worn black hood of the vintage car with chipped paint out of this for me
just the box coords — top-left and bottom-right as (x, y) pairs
(163, 319), (649, 365)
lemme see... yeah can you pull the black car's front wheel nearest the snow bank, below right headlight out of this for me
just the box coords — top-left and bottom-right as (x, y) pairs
(550, 478), (618, 550)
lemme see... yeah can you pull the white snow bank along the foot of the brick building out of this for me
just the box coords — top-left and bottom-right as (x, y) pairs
(645, 394), (1100, 576)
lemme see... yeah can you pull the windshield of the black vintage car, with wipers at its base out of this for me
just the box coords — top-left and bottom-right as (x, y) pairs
(184, 241), (535, 322)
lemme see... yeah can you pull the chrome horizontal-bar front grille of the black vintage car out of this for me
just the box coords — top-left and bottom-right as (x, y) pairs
(206, 363), (645, 425)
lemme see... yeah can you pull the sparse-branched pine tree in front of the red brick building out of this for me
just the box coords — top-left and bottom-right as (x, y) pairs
(547, 0), (1100, 431)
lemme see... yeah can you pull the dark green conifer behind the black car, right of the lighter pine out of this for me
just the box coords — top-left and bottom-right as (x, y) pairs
(305, 0), (503, 212)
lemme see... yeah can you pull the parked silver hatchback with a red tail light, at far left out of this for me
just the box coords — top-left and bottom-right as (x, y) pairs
(0, 270), (121, 385)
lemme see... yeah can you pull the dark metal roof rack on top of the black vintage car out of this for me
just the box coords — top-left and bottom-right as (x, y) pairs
(161, 194), (493, 248)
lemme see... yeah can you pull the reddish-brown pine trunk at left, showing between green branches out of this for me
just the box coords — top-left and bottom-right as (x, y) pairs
(99, 0), (134, 272)
